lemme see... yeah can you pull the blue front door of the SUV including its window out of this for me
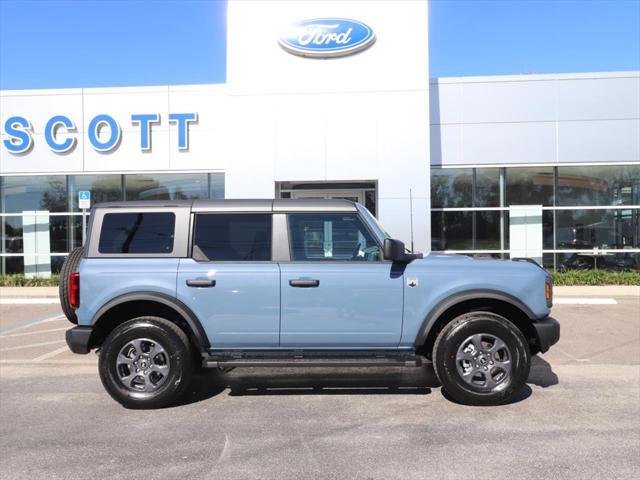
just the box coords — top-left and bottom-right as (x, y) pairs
(280, 213), (403, 349)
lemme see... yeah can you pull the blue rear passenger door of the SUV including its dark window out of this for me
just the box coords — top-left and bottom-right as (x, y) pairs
(177, 212), (280, 349)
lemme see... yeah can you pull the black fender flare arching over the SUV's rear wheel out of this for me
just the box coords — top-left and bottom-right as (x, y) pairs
(89, 292), (210, 352)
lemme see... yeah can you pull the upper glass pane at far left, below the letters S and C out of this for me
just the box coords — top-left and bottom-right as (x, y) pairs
(1, 175), (69, 213)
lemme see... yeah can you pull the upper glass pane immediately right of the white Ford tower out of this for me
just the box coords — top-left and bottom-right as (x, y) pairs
(431, 168), (472, 208)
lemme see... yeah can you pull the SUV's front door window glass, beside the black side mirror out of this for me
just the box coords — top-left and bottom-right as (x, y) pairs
(289, 213), (381, 262)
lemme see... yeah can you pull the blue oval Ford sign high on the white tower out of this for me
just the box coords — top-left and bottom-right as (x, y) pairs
(279, 18), (376, 58)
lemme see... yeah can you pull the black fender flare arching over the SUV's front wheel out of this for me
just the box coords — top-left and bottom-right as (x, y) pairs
(415, 290), (539, 358)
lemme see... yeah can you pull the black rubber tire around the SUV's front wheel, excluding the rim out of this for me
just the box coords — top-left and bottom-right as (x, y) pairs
(432, 312), (531, 405)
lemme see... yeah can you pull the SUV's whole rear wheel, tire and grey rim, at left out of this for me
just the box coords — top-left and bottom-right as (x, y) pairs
(99, 317), (192, 408)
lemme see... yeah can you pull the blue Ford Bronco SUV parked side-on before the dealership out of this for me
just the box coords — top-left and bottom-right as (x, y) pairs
(60, 200), (560, 408)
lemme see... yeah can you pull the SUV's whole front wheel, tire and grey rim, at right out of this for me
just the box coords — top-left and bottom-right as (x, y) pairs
(433, 312), (531, 405)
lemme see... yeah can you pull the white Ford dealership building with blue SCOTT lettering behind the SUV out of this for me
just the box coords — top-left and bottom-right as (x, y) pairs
(0, 1), (640, 276)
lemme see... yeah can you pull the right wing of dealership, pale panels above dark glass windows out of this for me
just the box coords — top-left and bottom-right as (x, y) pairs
(430, 72), (640, 270)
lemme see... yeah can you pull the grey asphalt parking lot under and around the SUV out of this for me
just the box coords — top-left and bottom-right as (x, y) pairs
(0, 297), (640, 480)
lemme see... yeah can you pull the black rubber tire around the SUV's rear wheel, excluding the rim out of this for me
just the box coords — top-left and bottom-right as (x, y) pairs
(98, 316), (193, 409)
